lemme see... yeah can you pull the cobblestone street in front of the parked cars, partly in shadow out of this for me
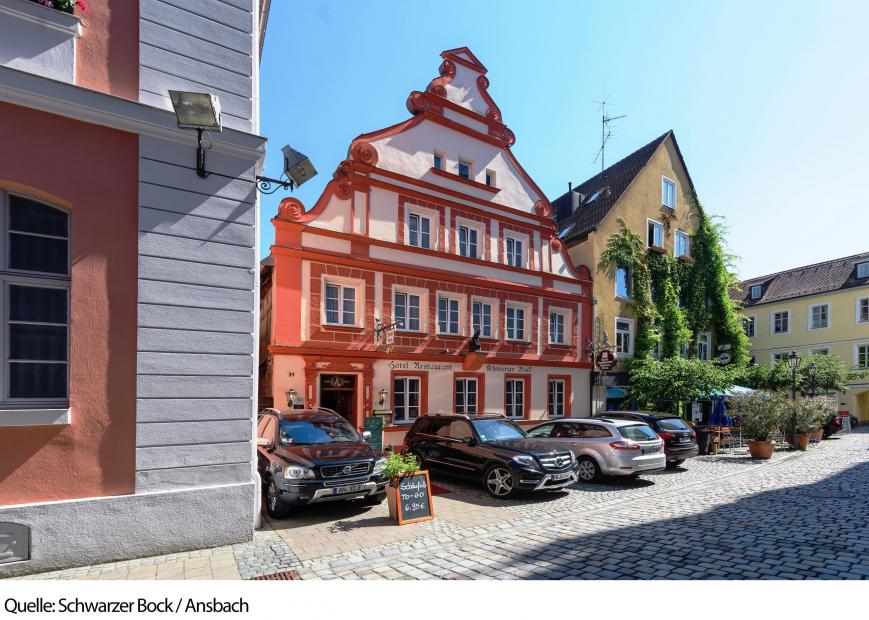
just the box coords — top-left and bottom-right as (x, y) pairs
(18, 432), (869, 579)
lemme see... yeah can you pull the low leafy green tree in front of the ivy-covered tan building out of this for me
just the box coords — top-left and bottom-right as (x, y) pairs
(628, 357), (733, 414)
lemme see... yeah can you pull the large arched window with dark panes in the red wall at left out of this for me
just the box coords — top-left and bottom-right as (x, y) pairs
(0, 190), (70, 410)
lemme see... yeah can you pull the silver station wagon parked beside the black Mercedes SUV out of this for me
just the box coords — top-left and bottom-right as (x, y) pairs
(528, 417), (667, 482)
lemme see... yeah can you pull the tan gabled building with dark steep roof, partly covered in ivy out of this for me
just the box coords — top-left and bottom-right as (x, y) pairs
(552, 130), (714, 401)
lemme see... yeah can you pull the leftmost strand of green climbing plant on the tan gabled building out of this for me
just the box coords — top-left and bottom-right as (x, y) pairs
(599, 218), (658, 359)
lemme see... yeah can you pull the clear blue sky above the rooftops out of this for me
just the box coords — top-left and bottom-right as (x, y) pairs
(261, 0), (869, 277)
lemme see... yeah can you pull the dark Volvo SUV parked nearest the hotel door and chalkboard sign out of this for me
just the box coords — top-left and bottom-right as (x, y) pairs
(257, 409), (387, 519)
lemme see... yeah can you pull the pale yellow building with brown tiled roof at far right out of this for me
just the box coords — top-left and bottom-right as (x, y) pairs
(738, 252), (869, 422)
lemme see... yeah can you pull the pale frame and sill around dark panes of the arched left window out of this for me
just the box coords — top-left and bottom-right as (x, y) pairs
(0, 189), (73, 418)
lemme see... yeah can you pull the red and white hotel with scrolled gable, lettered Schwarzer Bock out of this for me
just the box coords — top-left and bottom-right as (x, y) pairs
(260, 48), (592, 444)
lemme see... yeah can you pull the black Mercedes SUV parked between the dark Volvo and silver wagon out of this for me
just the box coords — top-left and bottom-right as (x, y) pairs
(404, 414), (577, 498)
